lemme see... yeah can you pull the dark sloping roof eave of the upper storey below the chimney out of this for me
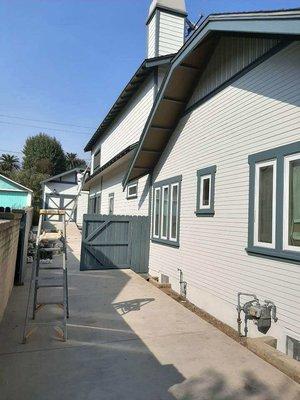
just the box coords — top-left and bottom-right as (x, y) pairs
(84, 54), (174, 151)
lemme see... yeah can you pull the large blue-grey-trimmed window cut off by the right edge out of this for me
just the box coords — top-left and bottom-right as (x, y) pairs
(247, 142), (300, 260)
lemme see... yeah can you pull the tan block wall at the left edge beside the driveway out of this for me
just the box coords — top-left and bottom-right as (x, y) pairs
(0, 220), (20, 321)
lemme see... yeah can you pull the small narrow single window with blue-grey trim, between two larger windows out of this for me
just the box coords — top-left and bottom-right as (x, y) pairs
(195, 166), (216, 216)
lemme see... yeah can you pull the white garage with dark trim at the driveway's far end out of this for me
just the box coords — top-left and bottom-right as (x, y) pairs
(42, 168), (89, 227)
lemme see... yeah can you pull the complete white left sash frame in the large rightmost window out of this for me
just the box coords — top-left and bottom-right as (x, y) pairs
(253, 159), (277, 249)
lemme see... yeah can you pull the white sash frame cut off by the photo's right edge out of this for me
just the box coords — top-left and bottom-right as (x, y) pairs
(282, 153), (300, 252)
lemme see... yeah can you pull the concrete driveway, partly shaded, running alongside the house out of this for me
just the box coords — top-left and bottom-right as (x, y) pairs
(0, 227), (300, 400)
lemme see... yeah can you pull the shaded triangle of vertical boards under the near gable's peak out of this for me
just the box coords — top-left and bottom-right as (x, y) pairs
(188, 37), (278, 107)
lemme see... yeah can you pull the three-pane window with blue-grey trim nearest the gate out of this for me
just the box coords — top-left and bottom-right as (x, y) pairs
(152, 176), (182, 246)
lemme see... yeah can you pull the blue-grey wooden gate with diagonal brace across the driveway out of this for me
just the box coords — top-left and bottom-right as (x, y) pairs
(80, 214), (150, 273)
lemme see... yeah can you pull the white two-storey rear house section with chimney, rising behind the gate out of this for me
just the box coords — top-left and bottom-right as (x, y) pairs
(85, 0), (186, 215)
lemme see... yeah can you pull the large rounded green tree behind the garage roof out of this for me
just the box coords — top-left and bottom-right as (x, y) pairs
(23, 133), (66, 175)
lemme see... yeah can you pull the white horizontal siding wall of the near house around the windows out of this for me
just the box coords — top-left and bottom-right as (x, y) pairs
(150, 42), (300, 350)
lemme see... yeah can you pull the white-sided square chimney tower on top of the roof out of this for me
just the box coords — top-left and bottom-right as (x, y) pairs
(146, 0), (187, 58)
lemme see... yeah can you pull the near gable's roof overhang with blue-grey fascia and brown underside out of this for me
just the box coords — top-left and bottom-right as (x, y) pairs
(123, 9), (300, 187)
